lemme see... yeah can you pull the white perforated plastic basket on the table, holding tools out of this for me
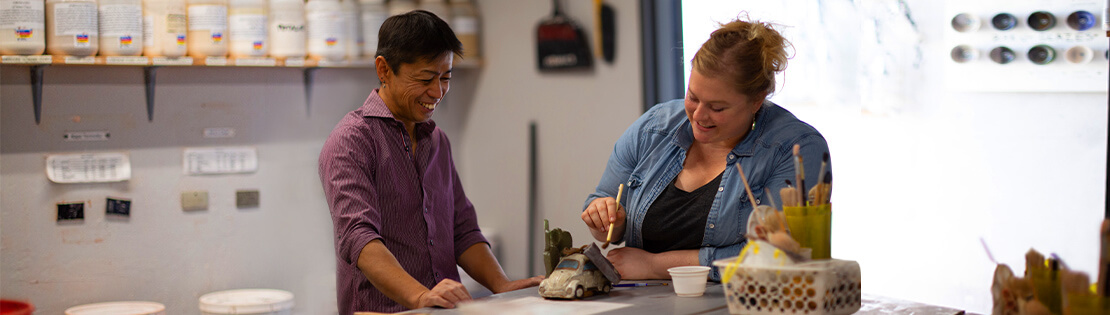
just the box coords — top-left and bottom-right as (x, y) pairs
(713, 257), (861, 315)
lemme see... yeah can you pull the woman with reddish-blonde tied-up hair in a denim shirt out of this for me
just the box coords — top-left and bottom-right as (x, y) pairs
(582, 20), (831, 281)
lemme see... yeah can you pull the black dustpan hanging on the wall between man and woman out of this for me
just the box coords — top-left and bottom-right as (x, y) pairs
(536, 0), (594, 71)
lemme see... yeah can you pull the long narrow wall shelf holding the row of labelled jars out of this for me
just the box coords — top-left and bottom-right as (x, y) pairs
(0, 54), (482, 69)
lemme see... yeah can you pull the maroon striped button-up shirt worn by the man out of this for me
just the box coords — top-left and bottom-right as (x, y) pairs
(320, 90), (486, 315)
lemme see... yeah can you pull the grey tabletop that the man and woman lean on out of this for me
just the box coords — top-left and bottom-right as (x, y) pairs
(402, 281), (965, 315)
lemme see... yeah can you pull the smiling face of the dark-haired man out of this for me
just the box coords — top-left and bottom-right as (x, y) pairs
(375, 52), (455, 131)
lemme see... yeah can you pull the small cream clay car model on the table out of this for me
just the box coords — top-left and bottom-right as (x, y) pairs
(539, 254), (613, 298)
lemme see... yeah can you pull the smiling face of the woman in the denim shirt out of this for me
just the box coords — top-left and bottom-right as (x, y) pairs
(686, 70), (763, 148)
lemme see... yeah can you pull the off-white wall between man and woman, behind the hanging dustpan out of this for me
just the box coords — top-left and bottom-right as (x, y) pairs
(452, 0), (643, 277)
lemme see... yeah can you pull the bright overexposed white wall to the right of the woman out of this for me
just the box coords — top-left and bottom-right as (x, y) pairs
(684, 0), (1107, 314)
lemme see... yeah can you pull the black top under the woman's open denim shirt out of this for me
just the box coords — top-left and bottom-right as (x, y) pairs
(642, 172), (725, 253)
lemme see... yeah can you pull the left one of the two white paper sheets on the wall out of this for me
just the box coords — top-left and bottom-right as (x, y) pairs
(47, 152), (131, 184)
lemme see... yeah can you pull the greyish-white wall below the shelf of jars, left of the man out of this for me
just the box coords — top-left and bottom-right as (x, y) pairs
(0, 65), (377, 314)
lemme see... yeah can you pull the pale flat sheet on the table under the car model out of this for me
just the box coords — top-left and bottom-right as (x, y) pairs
(458, 296), (632, 315)
